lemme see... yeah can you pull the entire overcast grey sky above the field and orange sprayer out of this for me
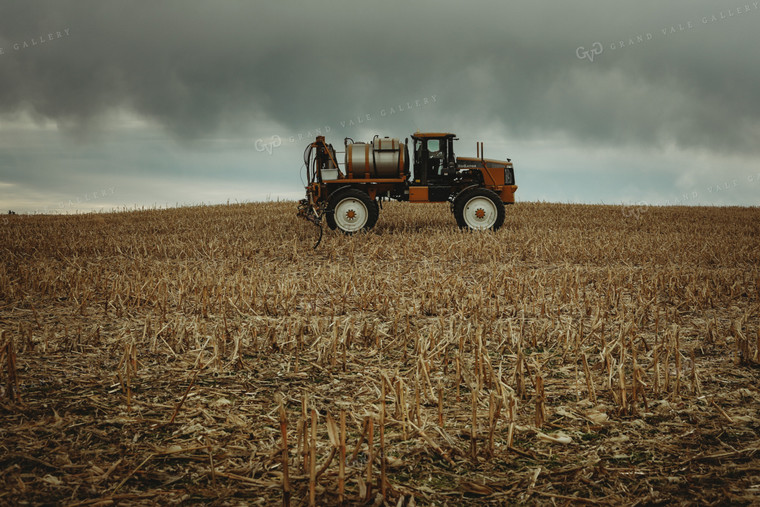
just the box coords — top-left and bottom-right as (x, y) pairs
(0, 0), (760, 213)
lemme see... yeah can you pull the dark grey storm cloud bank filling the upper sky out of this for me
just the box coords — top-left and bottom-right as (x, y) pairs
(0, 0), (760, 153)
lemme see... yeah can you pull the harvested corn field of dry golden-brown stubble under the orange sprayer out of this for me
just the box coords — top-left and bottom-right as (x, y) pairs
(0, 202), (760, 505)
